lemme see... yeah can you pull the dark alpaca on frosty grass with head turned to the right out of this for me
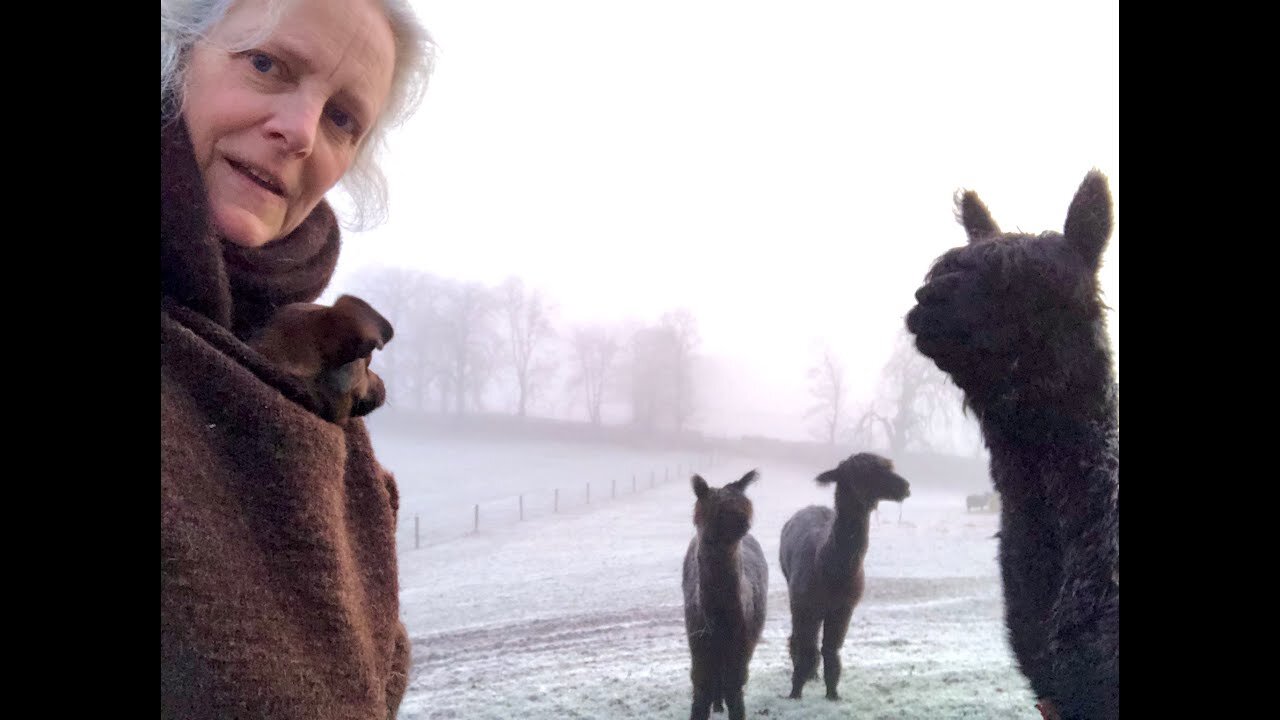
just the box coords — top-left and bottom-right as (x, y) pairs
(778, 452), (911, 700)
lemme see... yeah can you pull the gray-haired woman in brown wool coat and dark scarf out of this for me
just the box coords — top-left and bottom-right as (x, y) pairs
(160, 0), (433, 719)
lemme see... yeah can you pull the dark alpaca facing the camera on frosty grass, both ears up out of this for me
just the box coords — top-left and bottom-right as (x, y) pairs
(684, 470), (769, 720)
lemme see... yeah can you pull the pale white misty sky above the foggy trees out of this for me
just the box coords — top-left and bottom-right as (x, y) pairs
(326, 0), (1120, 437)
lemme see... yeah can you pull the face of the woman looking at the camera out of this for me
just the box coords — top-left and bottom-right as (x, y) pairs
(183, 0), (396, 247)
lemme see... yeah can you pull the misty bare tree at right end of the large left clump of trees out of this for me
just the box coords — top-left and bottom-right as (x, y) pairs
(499, 277), (556, 418)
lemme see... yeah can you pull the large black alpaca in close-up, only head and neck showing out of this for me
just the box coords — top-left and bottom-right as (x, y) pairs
(906, 170), (1120, 720)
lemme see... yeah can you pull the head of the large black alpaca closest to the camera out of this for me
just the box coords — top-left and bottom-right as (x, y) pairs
(906, 170), (1112, 413)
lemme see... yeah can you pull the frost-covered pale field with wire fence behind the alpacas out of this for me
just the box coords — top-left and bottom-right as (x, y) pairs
(374, 429), (1038, 720)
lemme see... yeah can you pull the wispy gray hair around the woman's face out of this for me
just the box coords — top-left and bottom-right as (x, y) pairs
(160, 0), (435, 229)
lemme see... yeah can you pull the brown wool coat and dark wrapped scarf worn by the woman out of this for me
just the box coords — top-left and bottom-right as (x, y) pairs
(160, 114), (408, 720)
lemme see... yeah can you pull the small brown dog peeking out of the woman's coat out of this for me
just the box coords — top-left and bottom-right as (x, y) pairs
(248, 295), (394, 424)
